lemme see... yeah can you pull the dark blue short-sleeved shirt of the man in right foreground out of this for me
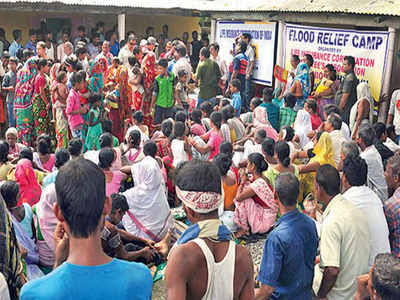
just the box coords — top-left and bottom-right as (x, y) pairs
(258, 210), (318, 300)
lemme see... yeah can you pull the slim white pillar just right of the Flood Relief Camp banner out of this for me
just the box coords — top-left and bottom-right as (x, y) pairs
(378, 27), (396, 123)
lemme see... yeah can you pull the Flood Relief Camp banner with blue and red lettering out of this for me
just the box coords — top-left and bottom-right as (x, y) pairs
(285, 24), (389, 101)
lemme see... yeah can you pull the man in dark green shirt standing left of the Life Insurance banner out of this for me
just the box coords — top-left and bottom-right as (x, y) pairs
(196, 47), (221, 108)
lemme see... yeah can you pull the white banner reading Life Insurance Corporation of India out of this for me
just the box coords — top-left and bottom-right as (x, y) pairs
(215, 21), (276, 86)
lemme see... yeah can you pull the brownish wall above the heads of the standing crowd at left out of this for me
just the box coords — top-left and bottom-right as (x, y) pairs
(0, 11), (200, 44)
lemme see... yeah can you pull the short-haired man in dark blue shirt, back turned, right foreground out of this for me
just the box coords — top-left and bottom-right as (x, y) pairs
(256, 173), (318, 300)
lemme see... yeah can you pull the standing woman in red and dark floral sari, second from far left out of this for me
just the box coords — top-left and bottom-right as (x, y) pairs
(33, 58), (52, 140)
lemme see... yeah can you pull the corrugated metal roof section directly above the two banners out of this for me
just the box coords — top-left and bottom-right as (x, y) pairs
(211, 0), (400, 16)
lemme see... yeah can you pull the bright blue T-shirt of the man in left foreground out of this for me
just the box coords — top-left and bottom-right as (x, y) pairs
(20, 259), (153, 300)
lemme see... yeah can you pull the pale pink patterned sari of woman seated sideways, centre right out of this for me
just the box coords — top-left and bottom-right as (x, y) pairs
(234, 178), (278, 233)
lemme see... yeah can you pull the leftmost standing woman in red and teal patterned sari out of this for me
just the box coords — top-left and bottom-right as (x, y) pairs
(14, 57), (38, 146)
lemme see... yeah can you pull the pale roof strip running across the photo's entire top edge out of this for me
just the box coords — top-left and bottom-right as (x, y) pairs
(0, 0), (400, 16)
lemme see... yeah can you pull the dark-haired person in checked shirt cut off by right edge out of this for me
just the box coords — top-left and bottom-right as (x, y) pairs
(383, 154), (400, 257)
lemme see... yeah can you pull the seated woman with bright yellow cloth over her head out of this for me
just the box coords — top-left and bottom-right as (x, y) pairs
(293, 132), (336, 202)
